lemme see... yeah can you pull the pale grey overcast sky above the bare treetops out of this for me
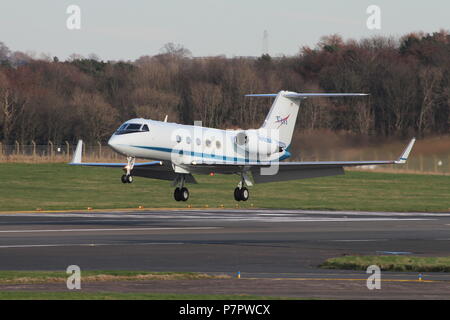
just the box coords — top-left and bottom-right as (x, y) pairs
(0, 0), (450, 60)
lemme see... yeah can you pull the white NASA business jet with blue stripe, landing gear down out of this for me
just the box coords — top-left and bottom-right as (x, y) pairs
(70, 91), (415, 201)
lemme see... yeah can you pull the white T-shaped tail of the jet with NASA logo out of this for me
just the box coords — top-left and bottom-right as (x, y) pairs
(246, 91), (367, 147)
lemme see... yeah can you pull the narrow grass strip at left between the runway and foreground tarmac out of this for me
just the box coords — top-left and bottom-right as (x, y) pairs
(0, 270), (230, 284)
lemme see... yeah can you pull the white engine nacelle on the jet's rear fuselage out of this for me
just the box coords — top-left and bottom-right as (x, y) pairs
(234, 130), (280, 155)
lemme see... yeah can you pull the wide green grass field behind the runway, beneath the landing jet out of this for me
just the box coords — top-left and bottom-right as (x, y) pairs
(0, 163), (450, 212)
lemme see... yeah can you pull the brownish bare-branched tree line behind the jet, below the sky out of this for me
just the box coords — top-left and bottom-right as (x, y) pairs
(0, 30), (450, 144)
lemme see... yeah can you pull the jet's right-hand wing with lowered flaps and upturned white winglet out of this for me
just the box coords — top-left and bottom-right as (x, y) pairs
(186, 139), (415, 183)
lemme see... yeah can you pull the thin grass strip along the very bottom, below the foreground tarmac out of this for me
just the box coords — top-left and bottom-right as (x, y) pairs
(0, 291), (292, 300)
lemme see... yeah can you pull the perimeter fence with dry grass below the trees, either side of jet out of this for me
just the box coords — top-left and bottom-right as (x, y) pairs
(0, 142), (450, 174)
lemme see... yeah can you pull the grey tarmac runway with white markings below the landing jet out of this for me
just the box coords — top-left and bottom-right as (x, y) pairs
(0, 209), (450, 298)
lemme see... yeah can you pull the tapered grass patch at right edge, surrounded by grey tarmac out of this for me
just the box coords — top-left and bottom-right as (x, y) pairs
(320, 255), (450, 272)
